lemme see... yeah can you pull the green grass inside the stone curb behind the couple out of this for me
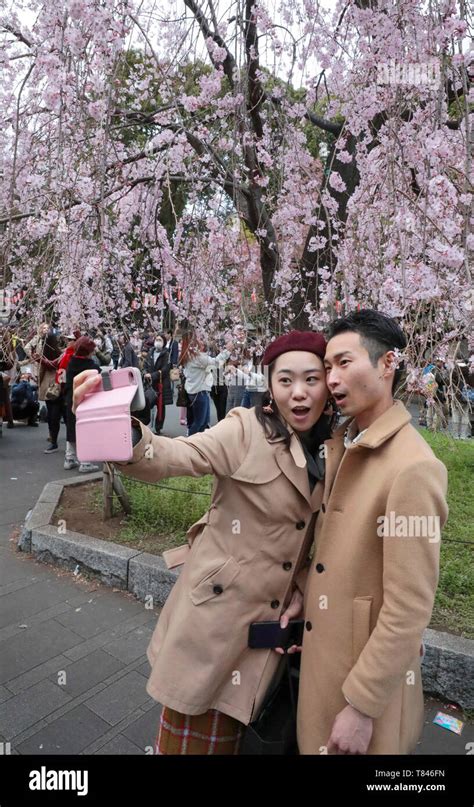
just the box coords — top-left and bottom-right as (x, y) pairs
(90, 429), (474, 638)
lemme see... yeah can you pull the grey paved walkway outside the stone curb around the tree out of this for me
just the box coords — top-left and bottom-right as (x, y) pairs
(0, 407), (474, 754)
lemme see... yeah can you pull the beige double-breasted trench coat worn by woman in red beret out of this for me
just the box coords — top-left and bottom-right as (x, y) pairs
(116, 407), (323, 724)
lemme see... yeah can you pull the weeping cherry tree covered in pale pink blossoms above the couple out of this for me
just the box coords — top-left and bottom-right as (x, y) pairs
(0, 0), (474, 387)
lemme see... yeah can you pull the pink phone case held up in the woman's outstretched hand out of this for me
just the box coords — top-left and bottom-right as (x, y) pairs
(76, 367), (137, 462)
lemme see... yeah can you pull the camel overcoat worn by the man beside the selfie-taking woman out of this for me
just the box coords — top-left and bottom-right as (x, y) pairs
(298, 402), (448, 754)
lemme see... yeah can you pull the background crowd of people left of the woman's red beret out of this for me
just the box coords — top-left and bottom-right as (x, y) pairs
(0, 322), (278, 473)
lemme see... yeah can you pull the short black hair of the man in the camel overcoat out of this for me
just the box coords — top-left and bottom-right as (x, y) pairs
(328, 308), (407, 392)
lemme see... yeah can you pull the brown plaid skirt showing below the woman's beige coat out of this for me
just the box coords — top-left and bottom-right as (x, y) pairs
(155, 706), (245, 755)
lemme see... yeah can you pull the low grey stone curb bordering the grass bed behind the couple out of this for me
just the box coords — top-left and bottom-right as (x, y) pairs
(18, 472), (474, 709)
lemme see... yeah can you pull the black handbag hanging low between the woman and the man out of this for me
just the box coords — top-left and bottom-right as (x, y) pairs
(239, 653), (300, 756)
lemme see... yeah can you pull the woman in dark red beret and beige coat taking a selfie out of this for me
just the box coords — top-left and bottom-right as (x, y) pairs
(74, 331), (330, 754)
